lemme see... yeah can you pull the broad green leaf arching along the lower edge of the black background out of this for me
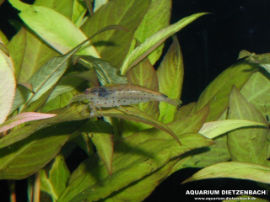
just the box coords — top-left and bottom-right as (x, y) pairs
(194, 61), (256, 121)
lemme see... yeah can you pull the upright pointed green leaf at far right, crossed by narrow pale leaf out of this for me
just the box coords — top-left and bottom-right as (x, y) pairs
(228, 88), (269, 164)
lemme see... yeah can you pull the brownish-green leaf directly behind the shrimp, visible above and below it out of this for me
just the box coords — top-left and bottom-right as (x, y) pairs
(127, 59), (159, 118)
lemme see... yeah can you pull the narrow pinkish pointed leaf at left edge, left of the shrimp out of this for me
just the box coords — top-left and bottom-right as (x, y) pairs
(0, 112), (56, 133)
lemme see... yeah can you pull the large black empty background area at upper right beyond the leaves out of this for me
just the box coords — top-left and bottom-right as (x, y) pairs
(172, 0), (270, 102)
